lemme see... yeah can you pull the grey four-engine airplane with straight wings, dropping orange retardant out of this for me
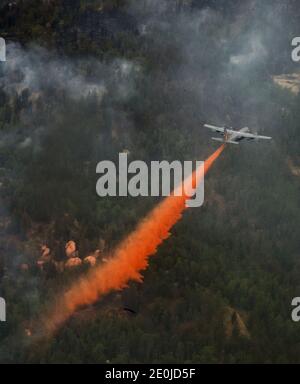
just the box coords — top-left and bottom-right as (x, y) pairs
(204, 124), (272, 145)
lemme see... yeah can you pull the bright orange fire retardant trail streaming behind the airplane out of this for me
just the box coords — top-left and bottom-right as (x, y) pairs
(45, 145), (225, 333)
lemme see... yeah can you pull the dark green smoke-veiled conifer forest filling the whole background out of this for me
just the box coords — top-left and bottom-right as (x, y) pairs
(0, 0), (300, 363)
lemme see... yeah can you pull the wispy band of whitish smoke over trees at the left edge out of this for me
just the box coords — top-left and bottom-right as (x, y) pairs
(0, 44), (140, 103)
